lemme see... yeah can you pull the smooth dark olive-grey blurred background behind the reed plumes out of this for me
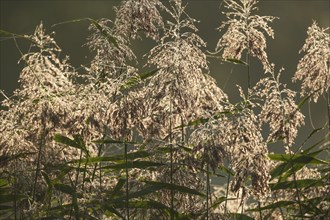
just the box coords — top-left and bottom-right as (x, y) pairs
(0, 0), (330, 153)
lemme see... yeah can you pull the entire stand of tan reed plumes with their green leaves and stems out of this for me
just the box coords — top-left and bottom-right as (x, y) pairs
(0, 0), (330, 219)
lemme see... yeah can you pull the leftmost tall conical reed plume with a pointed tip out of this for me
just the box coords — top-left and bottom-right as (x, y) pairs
(0, 24), (81, 162)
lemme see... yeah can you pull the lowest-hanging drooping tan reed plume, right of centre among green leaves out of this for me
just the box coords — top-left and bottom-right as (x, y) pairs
(191, 95), (269, 198)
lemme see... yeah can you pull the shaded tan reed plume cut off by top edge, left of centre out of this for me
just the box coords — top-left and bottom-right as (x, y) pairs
(115, 0), (165, 40)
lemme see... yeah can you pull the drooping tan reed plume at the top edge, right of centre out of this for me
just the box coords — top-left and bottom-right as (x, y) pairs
(216, 0), (275, 72)
